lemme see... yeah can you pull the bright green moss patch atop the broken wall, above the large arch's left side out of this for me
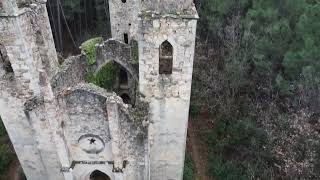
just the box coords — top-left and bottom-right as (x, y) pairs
(81, 37), (103, 65)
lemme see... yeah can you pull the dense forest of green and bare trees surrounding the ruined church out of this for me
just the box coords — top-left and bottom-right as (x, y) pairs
(0, 0), (320, 180)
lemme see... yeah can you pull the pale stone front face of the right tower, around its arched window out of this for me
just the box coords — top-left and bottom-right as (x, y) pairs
(139, 16), (197, 180)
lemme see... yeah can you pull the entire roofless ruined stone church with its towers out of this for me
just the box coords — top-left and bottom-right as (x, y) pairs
(0, 0), (198, 180)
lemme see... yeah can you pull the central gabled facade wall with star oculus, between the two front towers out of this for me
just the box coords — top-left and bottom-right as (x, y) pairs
(58, 84), (148, 179)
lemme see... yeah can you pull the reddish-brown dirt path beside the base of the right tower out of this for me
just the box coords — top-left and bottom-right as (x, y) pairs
(187, 115), (213, 180)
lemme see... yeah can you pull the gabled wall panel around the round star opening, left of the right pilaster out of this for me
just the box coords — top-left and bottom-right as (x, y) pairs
(58, 84), (113, 161)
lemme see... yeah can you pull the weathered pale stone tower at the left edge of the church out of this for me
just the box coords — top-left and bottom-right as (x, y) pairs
(0, 0), (63, 180)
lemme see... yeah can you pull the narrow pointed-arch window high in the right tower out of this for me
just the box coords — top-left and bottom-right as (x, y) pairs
(159, 41), (173, 74)
